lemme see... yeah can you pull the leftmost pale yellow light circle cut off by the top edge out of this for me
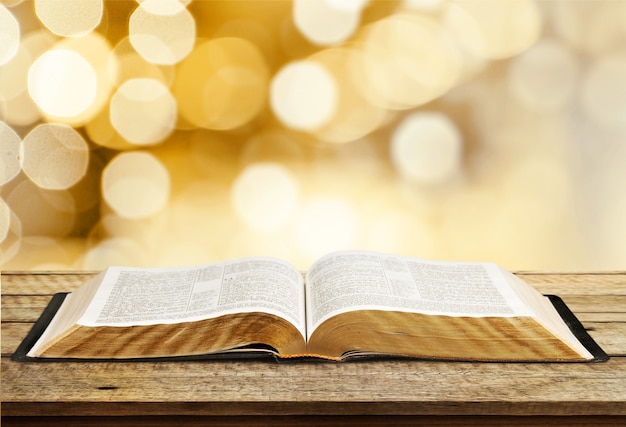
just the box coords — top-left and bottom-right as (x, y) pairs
(35, 0), (104, 37)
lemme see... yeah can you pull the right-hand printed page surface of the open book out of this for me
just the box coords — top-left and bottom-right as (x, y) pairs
(305, 252), (534, 337)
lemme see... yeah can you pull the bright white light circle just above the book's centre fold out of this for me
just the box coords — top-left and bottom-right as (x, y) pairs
(295, 196), (359, 259)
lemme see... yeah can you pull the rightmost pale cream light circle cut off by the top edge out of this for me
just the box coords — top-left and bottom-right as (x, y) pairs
(445, 0), (541, 60)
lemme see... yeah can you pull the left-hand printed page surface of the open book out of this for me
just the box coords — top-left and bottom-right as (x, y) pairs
(78, 258), (306, 337)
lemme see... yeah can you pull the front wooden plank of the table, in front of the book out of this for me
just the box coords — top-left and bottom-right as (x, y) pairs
(2, 358), (626, 416)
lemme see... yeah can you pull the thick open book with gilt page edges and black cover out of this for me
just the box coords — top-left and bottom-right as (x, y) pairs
(18, 251), (607, 361)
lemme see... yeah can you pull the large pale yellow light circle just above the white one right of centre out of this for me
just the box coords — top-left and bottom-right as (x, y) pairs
(351, 13), (461, 109)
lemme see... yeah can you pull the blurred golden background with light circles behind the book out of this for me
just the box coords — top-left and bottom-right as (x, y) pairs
(0, 0), (626, 270)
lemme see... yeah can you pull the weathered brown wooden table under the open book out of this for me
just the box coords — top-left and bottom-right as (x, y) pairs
(1, 272), (626, 426)
